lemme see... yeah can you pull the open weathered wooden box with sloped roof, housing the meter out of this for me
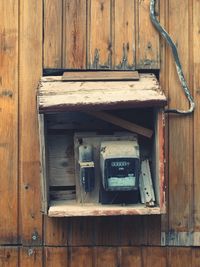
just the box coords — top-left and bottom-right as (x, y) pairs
(37, 74), (166, 217)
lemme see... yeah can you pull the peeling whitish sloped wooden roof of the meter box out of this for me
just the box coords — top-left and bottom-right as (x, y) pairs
(38, 74), (166, 112)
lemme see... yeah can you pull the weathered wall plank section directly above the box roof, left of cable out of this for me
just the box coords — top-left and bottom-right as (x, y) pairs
(44, 0), (160, 70)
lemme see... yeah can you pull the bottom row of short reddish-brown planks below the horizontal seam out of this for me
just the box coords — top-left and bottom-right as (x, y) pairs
(0, 246), (200, 267)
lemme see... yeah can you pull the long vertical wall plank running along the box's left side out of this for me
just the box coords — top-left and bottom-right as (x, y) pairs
(19, 0), (42, 245)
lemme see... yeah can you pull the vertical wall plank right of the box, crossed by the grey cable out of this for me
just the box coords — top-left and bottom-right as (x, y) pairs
(168, 0), (193, 232)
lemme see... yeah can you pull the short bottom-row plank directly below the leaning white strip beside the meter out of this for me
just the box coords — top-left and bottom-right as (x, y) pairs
(142, 247), (167, 267)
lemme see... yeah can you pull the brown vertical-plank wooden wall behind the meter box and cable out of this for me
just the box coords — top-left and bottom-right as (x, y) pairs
(0, 0), (200, 267)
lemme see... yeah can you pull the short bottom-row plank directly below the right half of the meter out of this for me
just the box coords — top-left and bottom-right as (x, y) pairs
(120, 247), (141, 267)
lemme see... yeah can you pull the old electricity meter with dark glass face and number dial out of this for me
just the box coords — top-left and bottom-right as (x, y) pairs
(100, 138), (140, 191)
